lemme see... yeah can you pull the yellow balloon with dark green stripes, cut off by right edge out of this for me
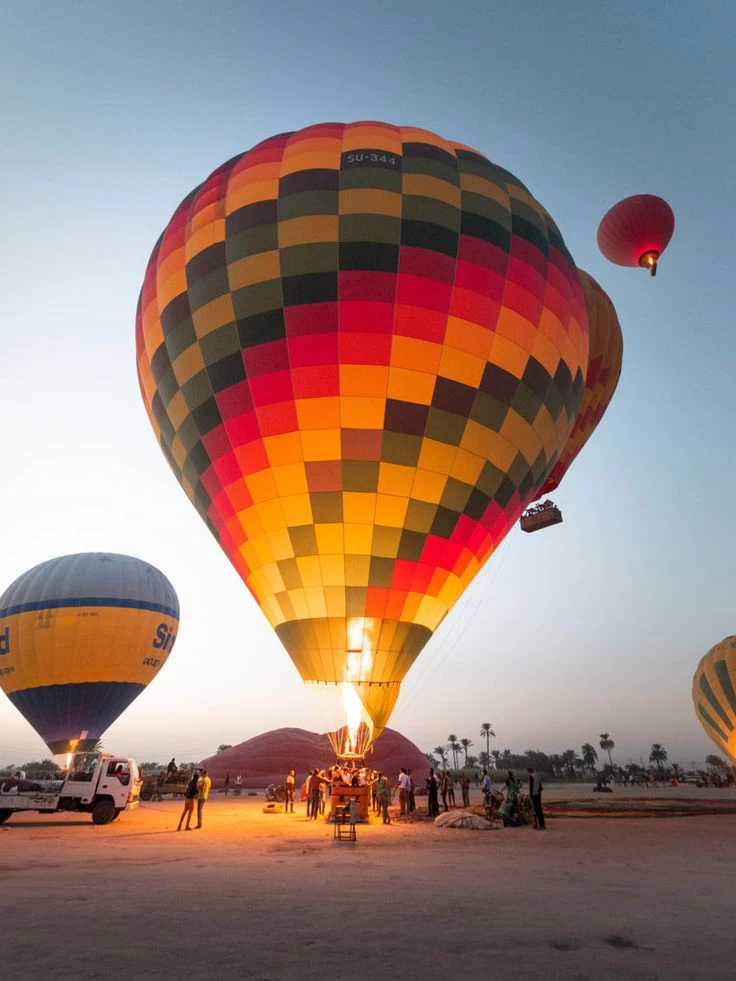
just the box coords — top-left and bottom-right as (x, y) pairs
(693, 637), (736, 763)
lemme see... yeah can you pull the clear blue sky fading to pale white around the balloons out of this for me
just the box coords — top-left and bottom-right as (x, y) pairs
(0, 0), (736, 763)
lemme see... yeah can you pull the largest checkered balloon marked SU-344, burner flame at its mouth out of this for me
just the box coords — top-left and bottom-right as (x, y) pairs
(136, 122), (608, 744)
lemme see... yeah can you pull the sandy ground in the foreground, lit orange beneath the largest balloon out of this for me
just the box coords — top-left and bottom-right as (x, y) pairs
(0, 787), (736, 981)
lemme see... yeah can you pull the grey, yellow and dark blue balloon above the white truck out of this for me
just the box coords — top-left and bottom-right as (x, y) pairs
(0, 552), (179, 753)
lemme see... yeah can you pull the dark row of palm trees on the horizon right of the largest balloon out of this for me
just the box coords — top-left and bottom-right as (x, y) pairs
(427, 722), (667, 777)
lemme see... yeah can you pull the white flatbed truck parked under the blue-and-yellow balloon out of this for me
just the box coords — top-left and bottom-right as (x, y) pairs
(0, 753), (143, 824)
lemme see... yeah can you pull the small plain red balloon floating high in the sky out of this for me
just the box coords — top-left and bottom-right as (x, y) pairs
(598, 194), (675, 276)
